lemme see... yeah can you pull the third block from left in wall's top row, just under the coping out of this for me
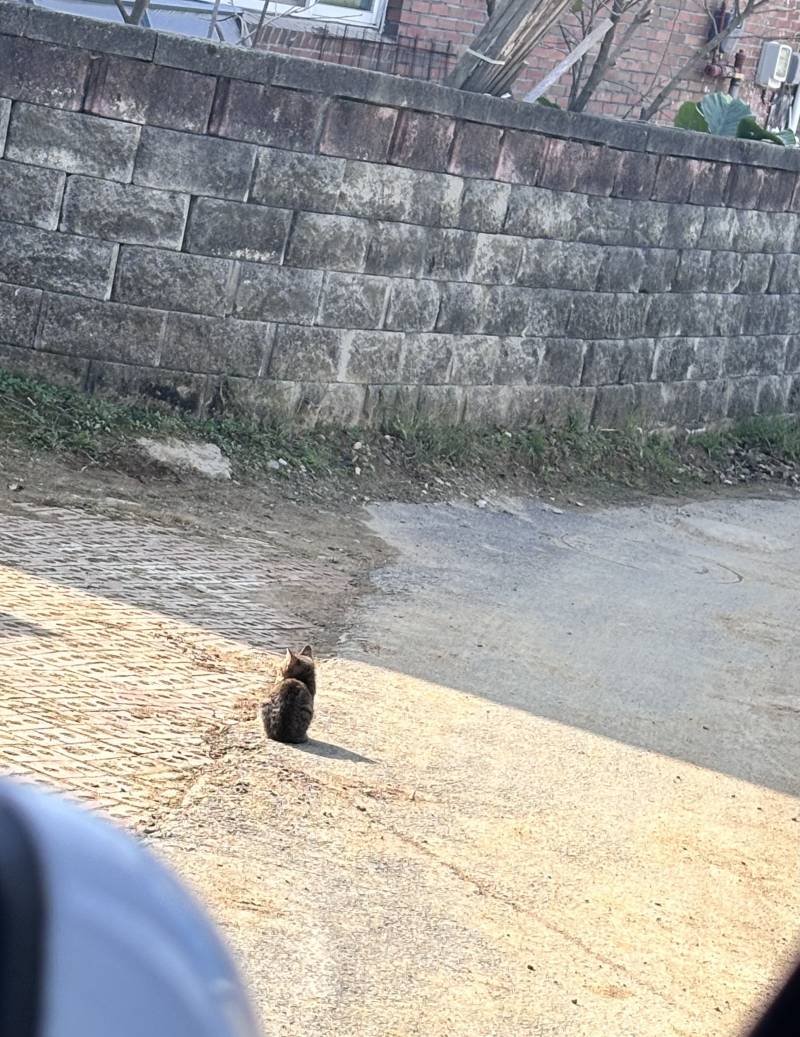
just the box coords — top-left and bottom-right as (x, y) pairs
(210, 79), (328, 151)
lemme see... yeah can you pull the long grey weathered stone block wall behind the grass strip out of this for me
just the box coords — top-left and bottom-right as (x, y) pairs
(0, 3), (800, 425)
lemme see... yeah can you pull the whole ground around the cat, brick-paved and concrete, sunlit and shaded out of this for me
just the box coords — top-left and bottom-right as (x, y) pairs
(0, 445), (800, 1037)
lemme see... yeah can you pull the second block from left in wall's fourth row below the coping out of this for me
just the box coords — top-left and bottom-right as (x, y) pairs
(113, 245), (234, 316)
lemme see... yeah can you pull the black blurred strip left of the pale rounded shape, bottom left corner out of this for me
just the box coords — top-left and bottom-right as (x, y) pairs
(0, 805), (45, 1037)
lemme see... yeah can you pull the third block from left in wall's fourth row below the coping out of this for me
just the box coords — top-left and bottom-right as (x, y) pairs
(236, 260), (324, 325)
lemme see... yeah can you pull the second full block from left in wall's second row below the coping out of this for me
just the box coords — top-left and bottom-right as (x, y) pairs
(133, 123), (255, 201)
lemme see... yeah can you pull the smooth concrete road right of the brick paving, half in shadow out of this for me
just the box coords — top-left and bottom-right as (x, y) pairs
(157, 491), (800, 1037)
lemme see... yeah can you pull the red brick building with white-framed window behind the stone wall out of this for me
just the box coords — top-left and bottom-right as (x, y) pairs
(255, 0), (800, 121)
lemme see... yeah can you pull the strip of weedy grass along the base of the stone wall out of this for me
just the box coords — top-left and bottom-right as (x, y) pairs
(0, 371), (800, 492)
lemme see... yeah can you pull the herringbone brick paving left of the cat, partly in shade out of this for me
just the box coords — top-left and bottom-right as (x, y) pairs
(0, 505), (334, 826)
